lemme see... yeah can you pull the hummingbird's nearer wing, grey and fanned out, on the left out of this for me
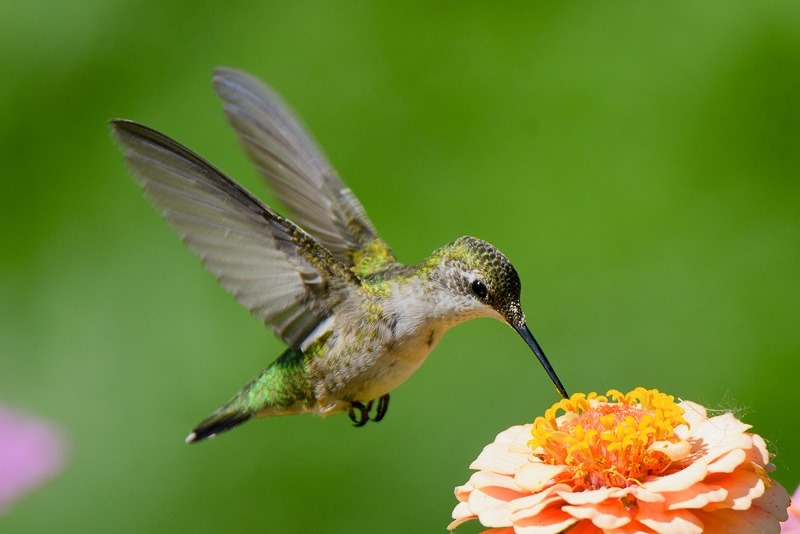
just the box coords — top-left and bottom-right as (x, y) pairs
(111, 120), (360, 348)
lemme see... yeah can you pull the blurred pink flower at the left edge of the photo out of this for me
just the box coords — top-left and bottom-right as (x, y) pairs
(0, 406), (64, 514)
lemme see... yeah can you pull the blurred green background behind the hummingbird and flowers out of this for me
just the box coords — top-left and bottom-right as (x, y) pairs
(0, 0), (800, 533)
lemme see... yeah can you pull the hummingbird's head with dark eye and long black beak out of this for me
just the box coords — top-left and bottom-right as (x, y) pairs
(438, 236), (568, 398)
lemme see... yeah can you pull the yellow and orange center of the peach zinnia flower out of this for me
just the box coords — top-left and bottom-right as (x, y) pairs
(528, 388), (686, 489)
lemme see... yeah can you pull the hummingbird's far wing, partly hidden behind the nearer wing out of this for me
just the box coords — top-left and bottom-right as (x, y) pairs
(214, 68), (396, 273)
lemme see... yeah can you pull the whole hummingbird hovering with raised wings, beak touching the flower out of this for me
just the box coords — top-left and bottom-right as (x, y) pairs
(110, 68), (568, 443)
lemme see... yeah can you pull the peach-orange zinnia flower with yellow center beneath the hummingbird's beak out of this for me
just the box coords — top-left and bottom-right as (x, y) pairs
(448, 388), (789, 534)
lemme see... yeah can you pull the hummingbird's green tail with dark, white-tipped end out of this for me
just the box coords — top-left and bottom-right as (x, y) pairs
(186, 349), (316, 443)
